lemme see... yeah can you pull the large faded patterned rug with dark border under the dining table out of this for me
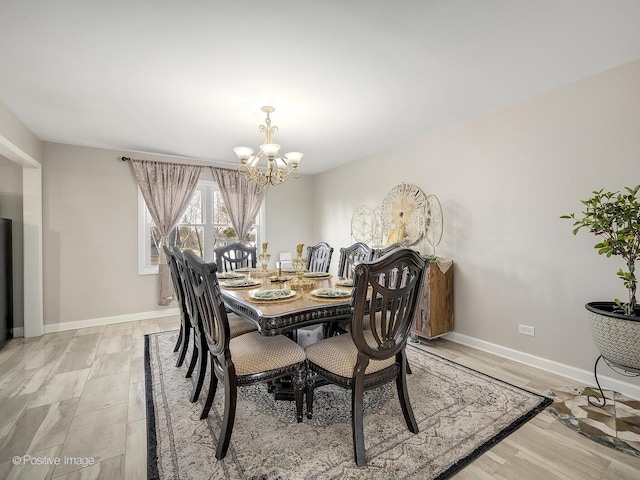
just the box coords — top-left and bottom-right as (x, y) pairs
(145, 332), (551, 480)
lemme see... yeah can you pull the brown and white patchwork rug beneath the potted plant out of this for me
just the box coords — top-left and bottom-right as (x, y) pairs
(545, 387), (640, 457)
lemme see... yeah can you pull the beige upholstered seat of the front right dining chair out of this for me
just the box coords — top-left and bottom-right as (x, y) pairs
(304, 331), (396, 379)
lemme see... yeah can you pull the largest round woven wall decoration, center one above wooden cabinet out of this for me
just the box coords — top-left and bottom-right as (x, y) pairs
(382, 183), (427, 245)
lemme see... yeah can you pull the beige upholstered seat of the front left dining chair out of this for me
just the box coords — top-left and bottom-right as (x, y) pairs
(229, 332), (305, 376)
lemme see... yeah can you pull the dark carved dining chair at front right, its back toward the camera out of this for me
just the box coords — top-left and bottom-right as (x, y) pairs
(305, 248), (428, 466)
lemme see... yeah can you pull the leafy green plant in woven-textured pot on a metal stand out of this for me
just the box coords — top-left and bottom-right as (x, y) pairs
(561, 185), (640, 386)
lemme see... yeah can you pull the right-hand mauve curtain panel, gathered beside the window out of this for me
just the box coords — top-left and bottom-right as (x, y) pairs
(211, 167), (267, 242)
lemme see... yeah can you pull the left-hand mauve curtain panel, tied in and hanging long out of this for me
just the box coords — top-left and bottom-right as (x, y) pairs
(131, 159), (204, 305)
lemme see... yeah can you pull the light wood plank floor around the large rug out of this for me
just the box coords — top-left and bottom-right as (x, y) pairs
(0, 317), (640, 480)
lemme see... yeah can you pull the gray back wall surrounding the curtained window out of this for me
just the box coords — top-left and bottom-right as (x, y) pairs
(42, 142), (312, 327)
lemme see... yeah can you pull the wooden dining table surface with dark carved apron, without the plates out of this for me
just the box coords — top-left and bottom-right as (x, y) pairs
(219, 269), (352, 336)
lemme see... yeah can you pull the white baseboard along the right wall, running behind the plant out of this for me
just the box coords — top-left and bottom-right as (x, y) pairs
(443, 332), (640, 399)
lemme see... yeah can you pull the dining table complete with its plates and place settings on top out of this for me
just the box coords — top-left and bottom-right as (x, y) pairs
(218, 269), (353, 336)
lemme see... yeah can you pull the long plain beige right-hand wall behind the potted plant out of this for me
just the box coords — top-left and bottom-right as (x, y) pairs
(314, 61), (640, 380)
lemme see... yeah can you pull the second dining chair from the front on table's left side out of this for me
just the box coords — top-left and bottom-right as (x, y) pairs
(170, 247), (258, 403)
